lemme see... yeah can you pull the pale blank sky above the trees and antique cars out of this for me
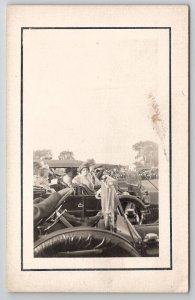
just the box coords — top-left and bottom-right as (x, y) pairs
(23, 30), (167, 164)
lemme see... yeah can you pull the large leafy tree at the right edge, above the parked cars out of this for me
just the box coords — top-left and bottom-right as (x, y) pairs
(132, 141), (158, 167)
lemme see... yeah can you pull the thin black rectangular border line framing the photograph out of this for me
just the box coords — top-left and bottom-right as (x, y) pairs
(20, 27), (173, 272)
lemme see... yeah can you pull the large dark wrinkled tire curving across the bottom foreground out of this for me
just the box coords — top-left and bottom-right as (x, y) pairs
(34, 227), (140, 257)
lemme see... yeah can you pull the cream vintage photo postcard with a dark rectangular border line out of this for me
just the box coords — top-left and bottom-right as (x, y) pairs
(7, 5), (189, 293)
